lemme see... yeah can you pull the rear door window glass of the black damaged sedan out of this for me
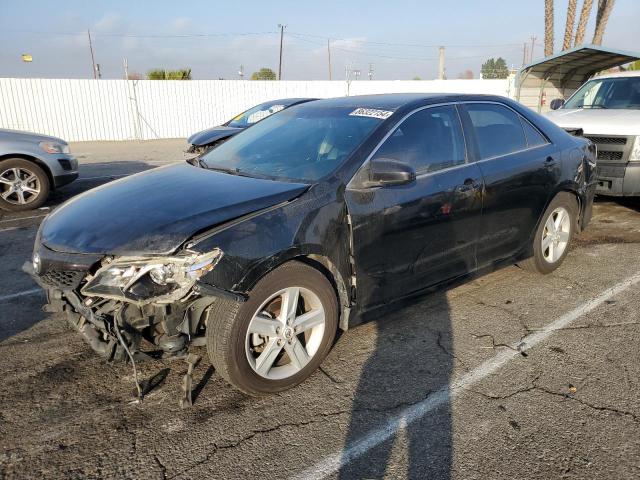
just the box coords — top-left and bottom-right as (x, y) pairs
(467, 103), (527, 160)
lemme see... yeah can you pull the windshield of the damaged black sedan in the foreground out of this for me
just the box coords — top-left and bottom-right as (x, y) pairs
(201, 103), (391, 182)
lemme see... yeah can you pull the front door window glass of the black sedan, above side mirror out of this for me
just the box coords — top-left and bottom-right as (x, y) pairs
(375, 106), (466, 174)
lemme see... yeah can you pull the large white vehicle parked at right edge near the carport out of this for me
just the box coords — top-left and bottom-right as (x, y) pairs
(547, 71), (640, 196)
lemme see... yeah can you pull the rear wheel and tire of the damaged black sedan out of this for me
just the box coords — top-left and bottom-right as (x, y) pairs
(518, 192), (578, 275)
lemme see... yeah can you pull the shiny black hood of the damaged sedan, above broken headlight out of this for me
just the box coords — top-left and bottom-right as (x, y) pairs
(40, 164), (308, 255)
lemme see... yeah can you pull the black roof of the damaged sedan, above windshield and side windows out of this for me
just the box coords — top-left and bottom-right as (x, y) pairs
(304, 93), (506, 111)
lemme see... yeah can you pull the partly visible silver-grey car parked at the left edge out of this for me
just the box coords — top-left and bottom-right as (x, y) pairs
(0, 129), (78, 211)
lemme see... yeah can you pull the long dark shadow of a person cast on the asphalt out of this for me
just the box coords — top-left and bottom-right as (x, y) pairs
(339, 292), (455, 479)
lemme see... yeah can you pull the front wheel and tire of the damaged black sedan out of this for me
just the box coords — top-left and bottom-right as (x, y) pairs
(206, 261), (338, 395)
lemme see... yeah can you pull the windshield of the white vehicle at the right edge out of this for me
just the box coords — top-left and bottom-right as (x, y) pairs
(564, 77), (640, 109)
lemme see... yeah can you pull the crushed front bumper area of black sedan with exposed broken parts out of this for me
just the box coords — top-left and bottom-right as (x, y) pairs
(23, 245), (242, 360)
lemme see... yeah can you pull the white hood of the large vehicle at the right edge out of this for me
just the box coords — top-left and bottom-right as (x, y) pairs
(546, 108), (640, 135)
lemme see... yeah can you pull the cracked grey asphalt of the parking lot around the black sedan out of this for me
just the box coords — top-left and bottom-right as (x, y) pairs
(0, 140), (640, 479)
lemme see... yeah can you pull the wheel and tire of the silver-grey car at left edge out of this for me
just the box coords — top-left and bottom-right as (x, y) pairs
(0, 158), (49, 211)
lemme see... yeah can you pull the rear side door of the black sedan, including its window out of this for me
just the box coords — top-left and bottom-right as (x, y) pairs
(463, 102), (561, 268)
